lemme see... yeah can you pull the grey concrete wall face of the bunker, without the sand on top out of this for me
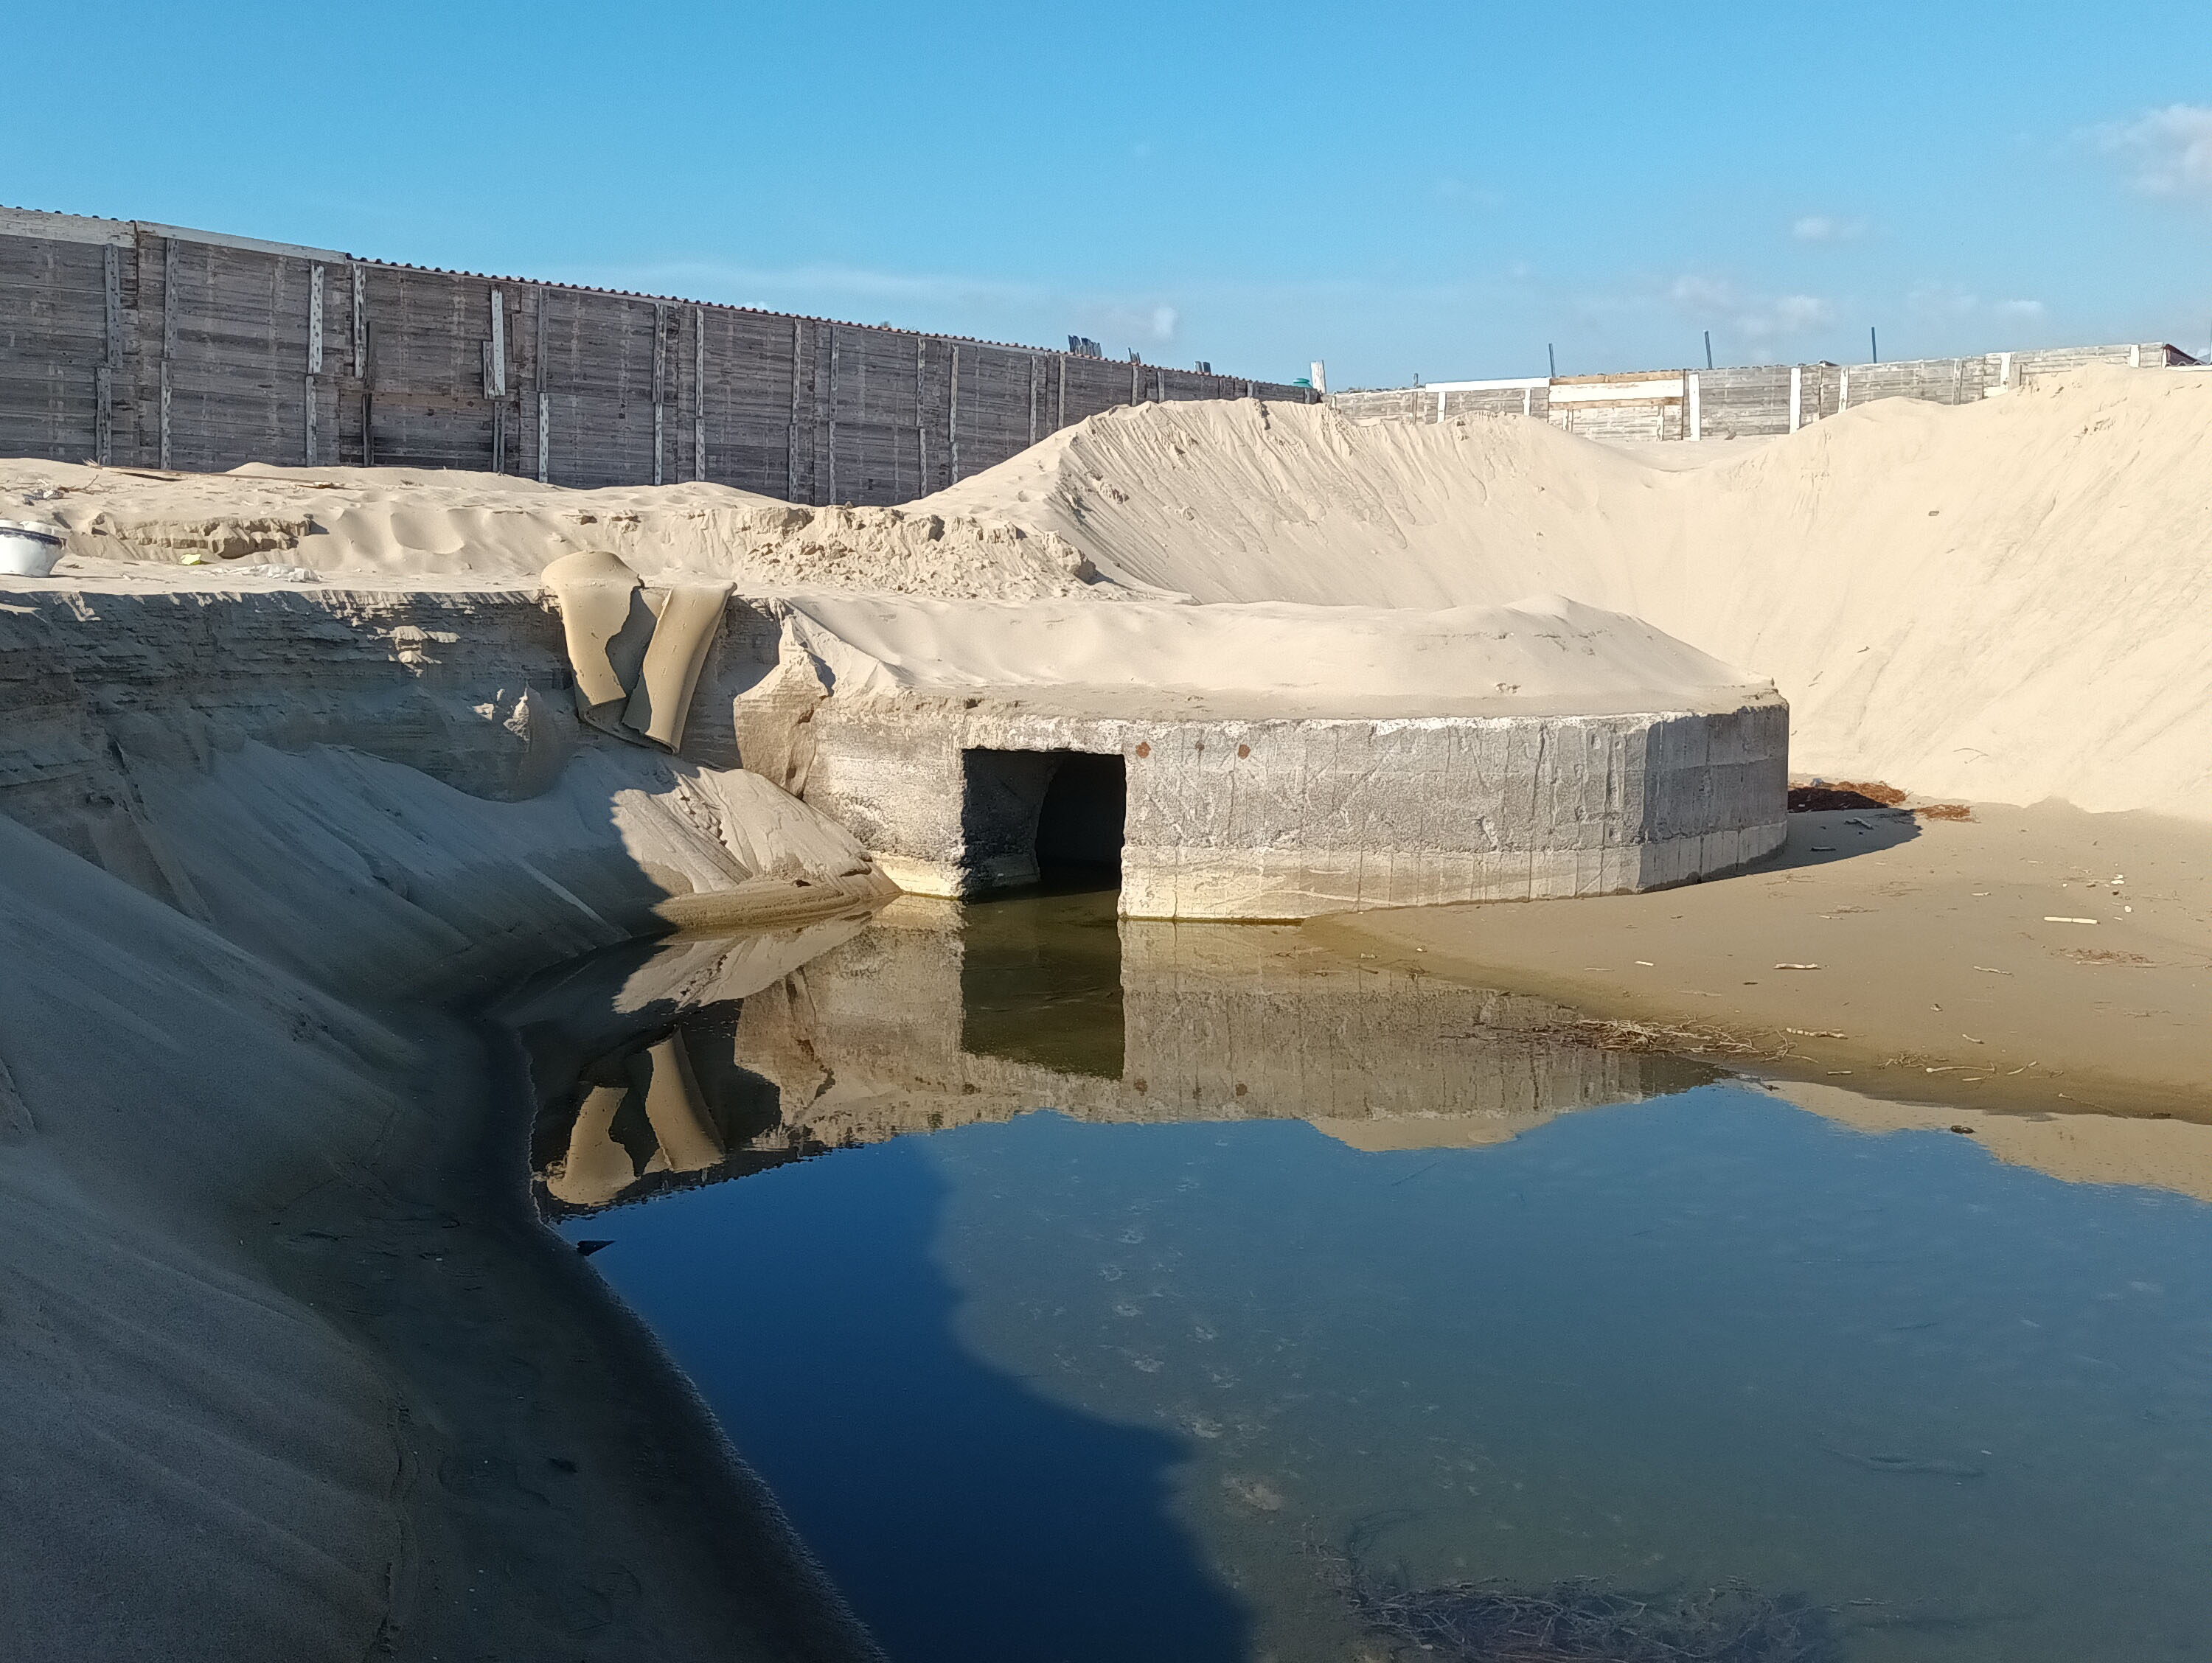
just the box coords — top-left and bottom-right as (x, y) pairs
(803, 697), (1790, 918)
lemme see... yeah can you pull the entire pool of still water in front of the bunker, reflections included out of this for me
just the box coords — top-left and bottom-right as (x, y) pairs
(509, 896), (2212, 1663)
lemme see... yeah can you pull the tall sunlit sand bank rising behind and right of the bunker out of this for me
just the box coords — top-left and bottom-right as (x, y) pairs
(916, 369), (2212, 818)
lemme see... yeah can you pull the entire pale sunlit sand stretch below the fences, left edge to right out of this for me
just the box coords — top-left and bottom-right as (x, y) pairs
(0, 369), (2212, 818)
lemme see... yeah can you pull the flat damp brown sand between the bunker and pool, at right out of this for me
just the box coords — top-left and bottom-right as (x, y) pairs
(1307, 805), (2212, 1141)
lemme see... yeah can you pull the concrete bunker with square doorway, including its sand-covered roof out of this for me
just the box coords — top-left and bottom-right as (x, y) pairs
(737, 597), (1790, 920)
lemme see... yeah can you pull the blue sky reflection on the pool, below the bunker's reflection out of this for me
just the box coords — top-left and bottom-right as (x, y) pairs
(571, 1086), (2212, 1663)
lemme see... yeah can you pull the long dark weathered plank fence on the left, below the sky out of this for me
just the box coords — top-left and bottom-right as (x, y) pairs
(0, 208), (1316, 504)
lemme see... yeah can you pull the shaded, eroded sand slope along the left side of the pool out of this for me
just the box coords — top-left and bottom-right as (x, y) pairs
(0, 593), (883, 1663)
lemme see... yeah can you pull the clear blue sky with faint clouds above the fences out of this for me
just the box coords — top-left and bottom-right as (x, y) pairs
(13, 0), (2212, 385)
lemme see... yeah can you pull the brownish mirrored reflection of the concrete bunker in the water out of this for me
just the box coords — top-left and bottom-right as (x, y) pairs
(502, 896), (1712, 1210)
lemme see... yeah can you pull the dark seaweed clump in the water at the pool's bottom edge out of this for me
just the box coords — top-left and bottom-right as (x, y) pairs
(1345, 1575), (1843, 1663)
